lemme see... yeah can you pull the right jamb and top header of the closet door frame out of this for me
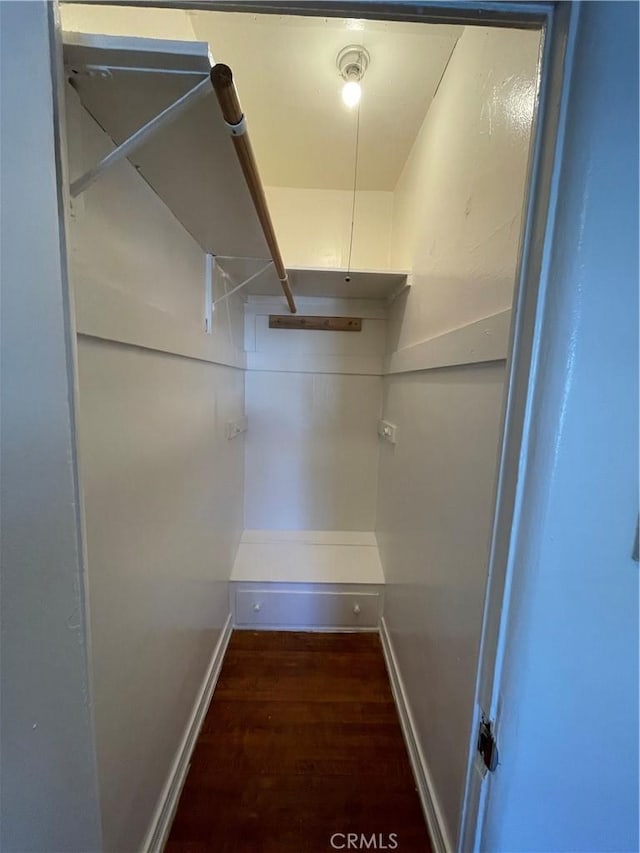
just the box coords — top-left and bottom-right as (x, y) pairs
(50, 0), (582, 851)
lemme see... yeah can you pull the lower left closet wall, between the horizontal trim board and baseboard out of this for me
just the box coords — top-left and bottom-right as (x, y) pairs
(79, 338), (243, 850)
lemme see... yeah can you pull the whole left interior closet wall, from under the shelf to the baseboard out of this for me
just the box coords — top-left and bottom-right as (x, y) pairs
(67, 85), (244, 850)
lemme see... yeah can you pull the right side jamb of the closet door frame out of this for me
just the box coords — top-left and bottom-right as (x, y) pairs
(458, 0), (581, 851)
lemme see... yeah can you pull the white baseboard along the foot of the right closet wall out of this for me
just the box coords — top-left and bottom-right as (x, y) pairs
(380, 616), (454, 853)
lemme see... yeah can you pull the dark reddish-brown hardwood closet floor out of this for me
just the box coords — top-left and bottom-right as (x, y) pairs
(165, 631), (431, 853)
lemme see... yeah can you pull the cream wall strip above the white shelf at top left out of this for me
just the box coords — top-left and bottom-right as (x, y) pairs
(60, 2), (196, 41)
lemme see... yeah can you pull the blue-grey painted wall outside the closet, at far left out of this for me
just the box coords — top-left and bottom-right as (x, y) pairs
(0, 2), (100, 853)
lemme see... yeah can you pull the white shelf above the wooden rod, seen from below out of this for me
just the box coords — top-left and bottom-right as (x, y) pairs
(63, 33), (268, 257)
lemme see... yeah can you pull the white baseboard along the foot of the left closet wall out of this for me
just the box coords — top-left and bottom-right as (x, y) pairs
(142, 614), (233, 853)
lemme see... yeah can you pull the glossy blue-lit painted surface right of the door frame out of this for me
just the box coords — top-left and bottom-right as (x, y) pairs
(481, 3), (639, 851)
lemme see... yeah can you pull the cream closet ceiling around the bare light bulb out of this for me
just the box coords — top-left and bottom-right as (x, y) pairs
(189, 11), (462, 191)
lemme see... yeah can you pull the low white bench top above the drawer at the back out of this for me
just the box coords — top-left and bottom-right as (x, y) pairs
(231, 530), (384, 584)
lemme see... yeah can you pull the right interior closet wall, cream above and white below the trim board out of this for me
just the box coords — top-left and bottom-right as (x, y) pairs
(376, 27), (538, 846)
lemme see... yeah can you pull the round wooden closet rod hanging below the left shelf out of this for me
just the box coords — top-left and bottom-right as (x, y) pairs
(211, 63), (297, 314)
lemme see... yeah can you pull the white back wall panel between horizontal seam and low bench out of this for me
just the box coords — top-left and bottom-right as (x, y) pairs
(245, 370), (382, 530)
